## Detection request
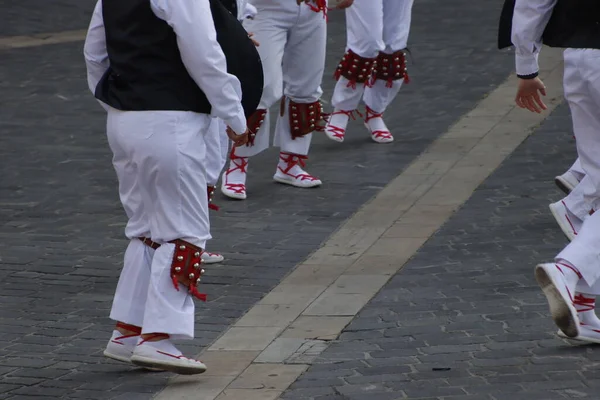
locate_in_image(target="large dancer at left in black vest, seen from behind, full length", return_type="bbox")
[84,0,262,374]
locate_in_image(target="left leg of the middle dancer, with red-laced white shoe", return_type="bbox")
[221,10,287,200]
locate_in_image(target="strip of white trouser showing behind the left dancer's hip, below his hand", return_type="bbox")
[206,118,229,186]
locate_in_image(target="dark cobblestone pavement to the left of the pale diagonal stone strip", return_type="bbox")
[0,0,516,400]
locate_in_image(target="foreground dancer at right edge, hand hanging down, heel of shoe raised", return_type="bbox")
[508,0,600,340]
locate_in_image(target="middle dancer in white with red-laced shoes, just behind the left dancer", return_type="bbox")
[221,0,352,200]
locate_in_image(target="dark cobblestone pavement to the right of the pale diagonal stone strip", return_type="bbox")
[282,105,600,400]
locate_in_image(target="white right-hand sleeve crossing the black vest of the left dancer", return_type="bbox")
[150,0,246,134]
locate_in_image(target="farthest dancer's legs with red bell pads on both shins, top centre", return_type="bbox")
[325,0,413,143]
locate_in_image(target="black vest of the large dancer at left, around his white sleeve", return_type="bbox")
[95,0,264,116]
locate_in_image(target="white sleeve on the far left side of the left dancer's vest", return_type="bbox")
[83,0,110,108]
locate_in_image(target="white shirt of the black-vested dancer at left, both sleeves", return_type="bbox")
[84,0,246,134]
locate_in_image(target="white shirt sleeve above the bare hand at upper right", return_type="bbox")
[511,0,557,75]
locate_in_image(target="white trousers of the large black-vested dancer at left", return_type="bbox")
[107,109,211,338]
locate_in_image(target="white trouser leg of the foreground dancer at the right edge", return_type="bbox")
[557,49,600,290]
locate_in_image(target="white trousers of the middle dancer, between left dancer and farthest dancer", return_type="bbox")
[235,0,327,157]
